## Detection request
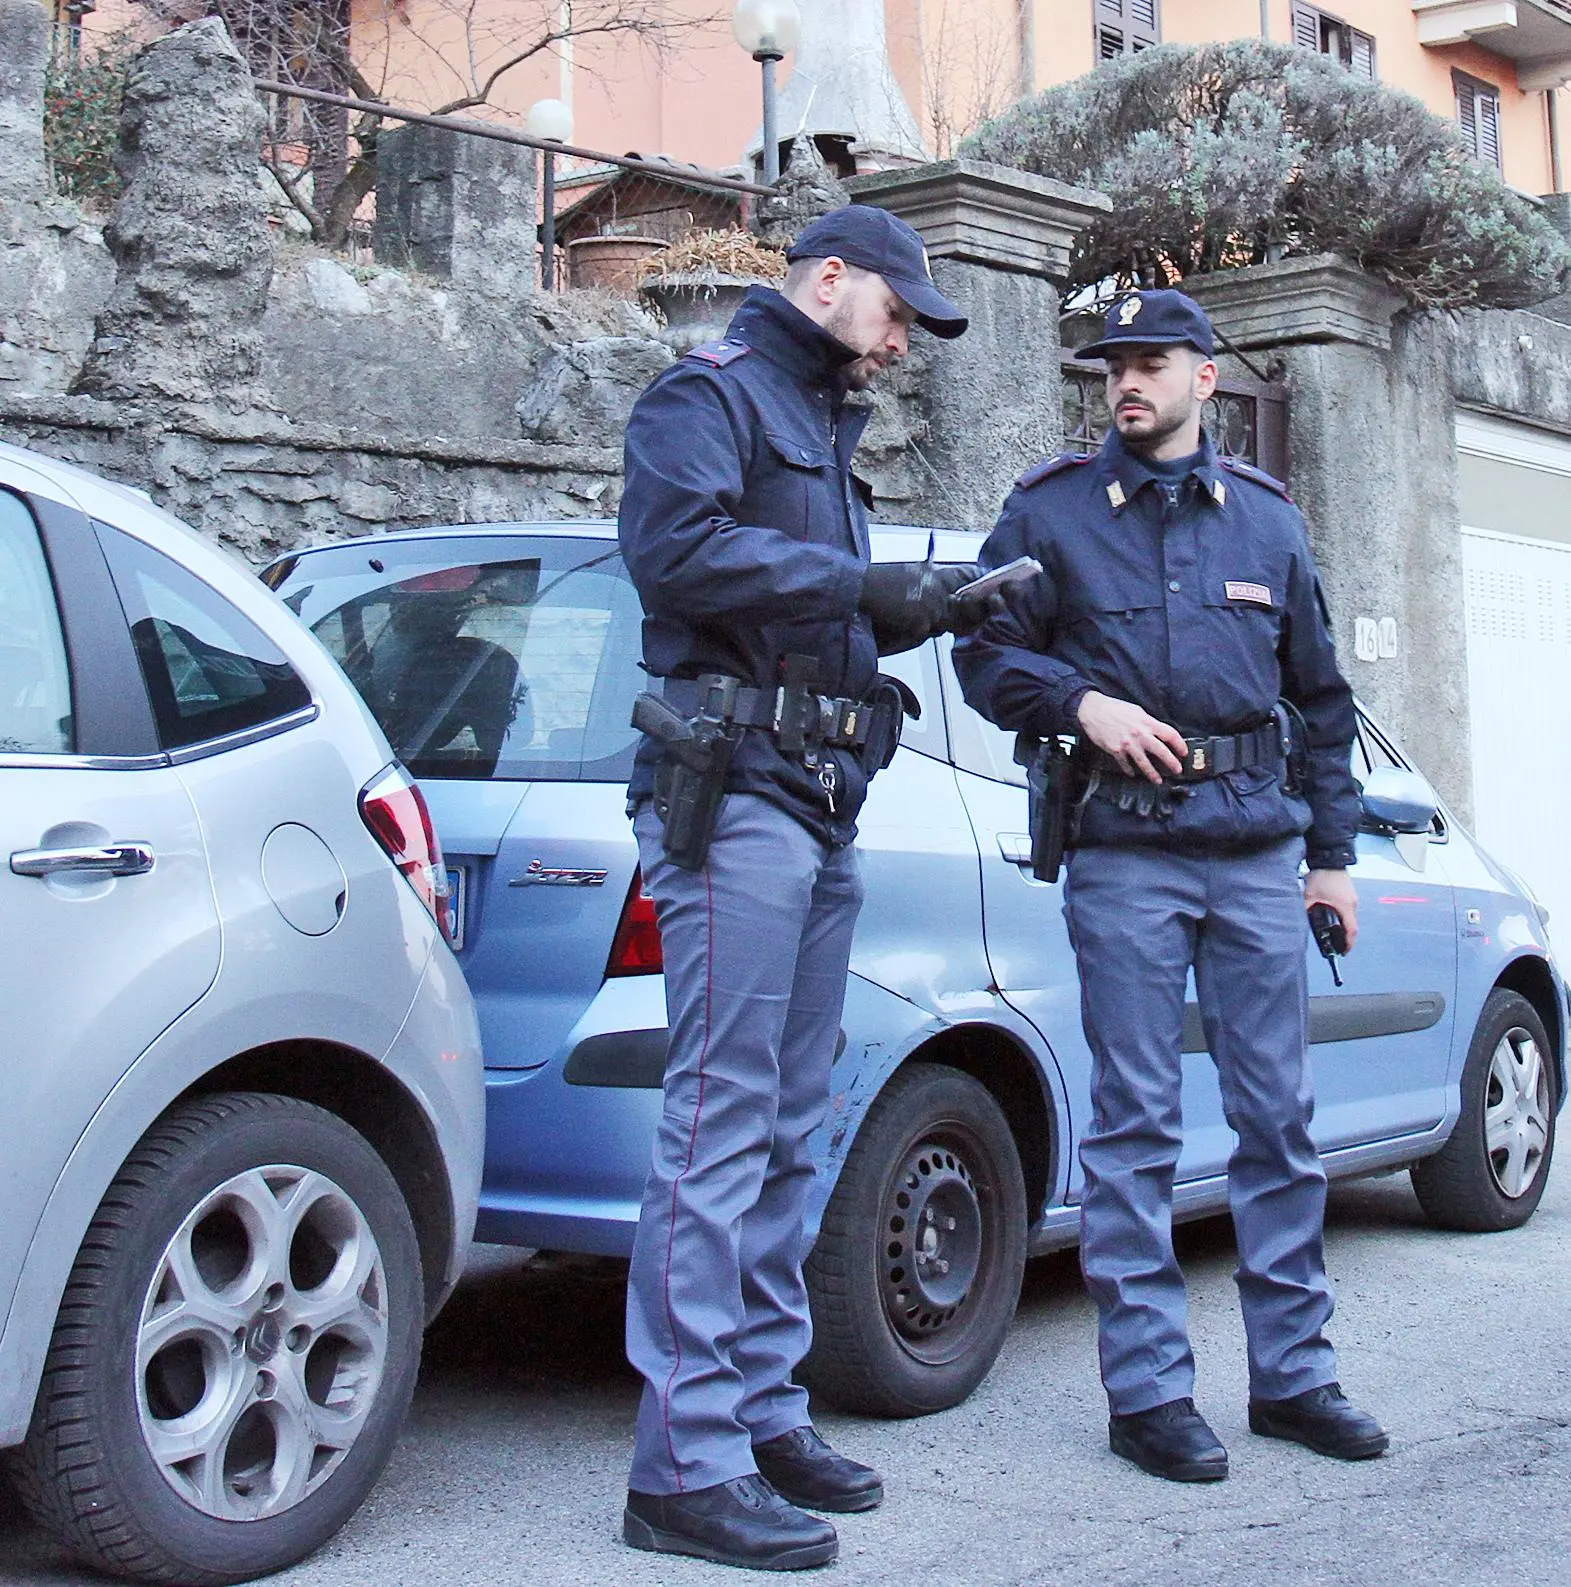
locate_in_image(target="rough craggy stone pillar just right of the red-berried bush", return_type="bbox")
[76,17,273,411]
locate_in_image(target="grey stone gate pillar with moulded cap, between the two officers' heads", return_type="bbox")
[847,160,1109,528]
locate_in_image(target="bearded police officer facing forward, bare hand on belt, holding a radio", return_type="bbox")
[955,292,1387,1482]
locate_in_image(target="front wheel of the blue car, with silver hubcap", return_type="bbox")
[1412,989,1557,1232]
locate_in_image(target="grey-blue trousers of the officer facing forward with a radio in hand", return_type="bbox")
[1065,838,1336,1414]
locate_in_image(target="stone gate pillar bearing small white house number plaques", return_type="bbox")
[1185,256,1473,819]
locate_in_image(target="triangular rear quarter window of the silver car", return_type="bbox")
[95,524,311,749]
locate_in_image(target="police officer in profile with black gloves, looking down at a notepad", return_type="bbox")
[620,205,982,1570]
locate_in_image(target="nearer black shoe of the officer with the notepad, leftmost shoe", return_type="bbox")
[622,1476,839,1571]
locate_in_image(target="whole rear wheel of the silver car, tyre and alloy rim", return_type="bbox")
[13,1092,424,1587]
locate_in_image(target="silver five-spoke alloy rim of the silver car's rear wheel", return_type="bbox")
[136,1165,387,1522]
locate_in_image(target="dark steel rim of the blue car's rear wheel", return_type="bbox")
[879,1136,987,1363]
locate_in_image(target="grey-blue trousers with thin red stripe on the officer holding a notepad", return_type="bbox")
[627,794,862,1493]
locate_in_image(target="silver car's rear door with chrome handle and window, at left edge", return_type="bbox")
[0,485,219,1339]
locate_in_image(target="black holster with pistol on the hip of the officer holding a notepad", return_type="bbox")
[633,673,743,871]
